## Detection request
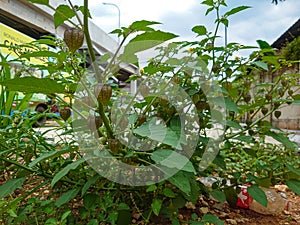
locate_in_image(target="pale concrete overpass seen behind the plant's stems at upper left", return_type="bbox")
[0,0,137,91]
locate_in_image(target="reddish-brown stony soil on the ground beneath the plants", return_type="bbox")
[0,171,300,225]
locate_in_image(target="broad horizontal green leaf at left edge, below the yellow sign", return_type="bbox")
[0,77,66,94]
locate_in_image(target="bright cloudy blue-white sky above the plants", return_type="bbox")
[72,0,300,51]
